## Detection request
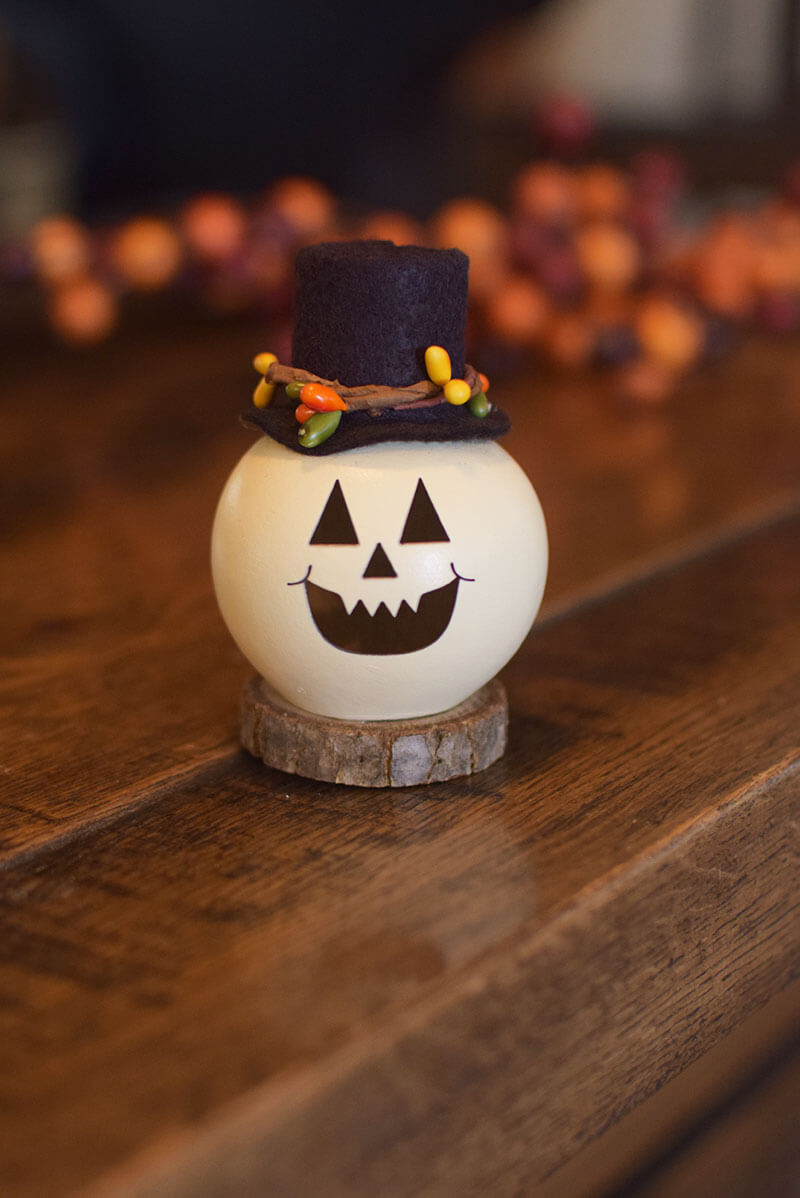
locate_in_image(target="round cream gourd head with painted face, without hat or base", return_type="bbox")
[212,437,547,720]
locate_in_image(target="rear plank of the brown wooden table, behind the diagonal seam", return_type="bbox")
[0,320,800,858]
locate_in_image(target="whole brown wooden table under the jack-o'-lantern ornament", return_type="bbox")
[0,319,800,1198]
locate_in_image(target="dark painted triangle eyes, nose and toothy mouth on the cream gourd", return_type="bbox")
[289,478,474,657]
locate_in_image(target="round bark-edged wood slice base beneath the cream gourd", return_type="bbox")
[240,674,508,786]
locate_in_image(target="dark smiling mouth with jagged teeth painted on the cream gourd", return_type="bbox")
[297,567,462,657]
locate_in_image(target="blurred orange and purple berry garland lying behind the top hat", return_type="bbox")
[0,139,800,405]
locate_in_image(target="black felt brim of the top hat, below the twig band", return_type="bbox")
[241,392,511,456]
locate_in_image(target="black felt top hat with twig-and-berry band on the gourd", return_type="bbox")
[243,241,509,455]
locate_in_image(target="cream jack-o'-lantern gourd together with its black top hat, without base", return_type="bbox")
[212,242,547,785]
